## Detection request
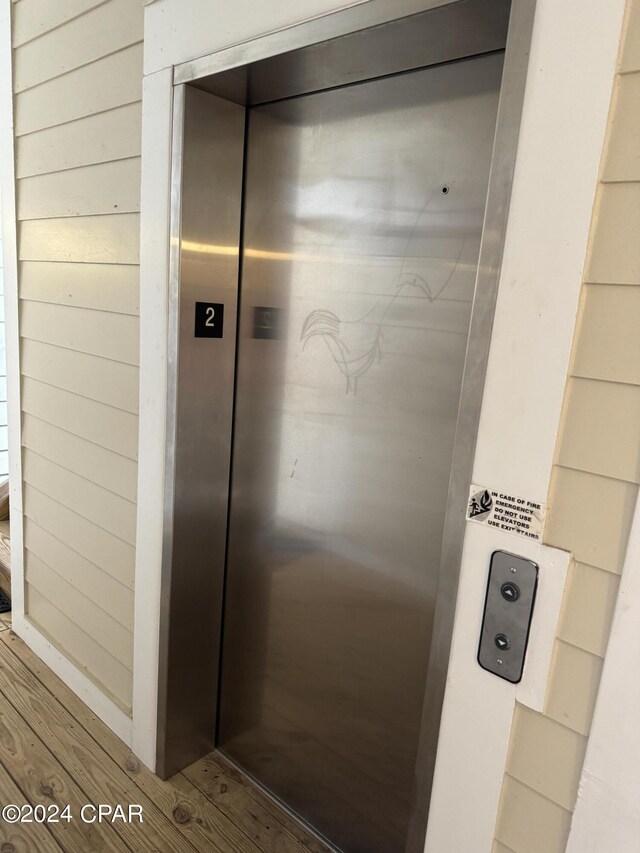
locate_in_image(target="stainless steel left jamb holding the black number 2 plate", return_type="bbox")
[157,87,244,777]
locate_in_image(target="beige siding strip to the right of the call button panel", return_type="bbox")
[494,0,640,853]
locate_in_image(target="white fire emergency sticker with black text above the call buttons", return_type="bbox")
[467,485,547,539]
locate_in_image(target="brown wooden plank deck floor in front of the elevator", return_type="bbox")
[0,616,328,853]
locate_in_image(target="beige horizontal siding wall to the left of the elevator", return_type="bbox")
[13,0,143,711]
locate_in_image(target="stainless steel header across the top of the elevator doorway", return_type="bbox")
[185,0,510,106]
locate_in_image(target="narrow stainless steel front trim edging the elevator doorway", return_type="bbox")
[157,6,536,853]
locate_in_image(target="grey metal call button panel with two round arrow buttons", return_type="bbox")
[478,551,538,684]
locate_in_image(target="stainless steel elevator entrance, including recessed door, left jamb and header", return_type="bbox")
[159,0,524,853]
